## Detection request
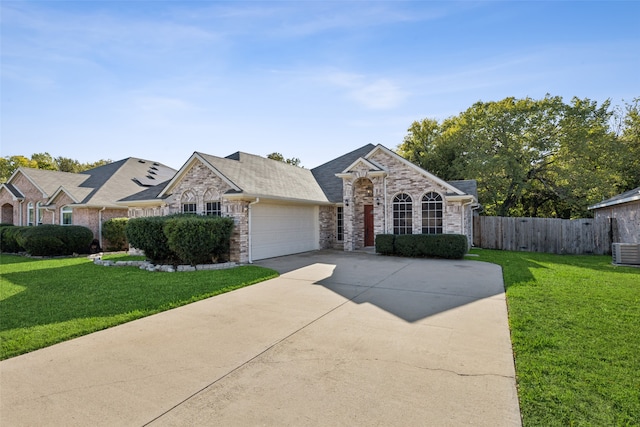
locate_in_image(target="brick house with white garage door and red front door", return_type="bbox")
[118,144,477,263]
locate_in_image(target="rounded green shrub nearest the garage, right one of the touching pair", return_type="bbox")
[163,216,233,265]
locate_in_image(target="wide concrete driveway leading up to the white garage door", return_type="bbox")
[0,251,521,426]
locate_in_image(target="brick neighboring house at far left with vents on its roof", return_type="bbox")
[0,158,176,246]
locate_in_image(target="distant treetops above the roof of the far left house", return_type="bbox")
[0,153,112,182]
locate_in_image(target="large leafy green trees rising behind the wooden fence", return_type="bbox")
[398,95,640,218]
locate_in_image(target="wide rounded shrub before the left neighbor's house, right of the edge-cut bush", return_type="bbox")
[17,224,93,256]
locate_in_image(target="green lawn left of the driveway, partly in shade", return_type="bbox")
[0,255,278,360]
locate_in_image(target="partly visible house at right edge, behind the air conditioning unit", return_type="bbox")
[589,187,640,244]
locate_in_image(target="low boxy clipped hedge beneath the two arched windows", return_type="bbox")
[376,234,468,259]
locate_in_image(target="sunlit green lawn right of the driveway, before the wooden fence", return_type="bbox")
[472,250,640,427]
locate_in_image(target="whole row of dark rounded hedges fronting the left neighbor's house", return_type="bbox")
[0,224,93,256]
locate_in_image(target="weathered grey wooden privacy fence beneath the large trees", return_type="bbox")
[473,216,615,255]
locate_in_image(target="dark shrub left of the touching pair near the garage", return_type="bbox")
[124,215,177,263]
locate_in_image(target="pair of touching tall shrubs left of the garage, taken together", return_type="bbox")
[125,214,234,265]
